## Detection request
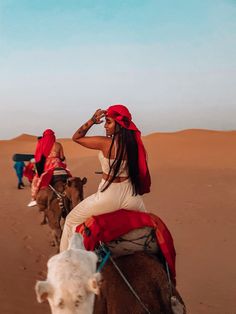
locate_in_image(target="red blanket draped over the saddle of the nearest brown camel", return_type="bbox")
[76,209,176,282]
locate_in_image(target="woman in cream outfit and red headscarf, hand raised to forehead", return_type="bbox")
[60,105,151,251]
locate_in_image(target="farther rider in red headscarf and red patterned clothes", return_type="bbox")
[28,129,69,207]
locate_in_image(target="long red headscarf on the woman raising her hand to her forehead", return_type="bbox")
[106,104,151,195]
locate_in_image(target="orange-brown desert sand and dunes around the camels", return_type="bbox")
[0,130,236,314]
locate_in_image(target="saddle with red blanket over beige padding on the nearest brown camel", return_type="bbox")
[75,209,176,282]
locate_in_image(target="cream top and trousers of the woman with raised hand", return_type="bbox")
[60,151,146,252]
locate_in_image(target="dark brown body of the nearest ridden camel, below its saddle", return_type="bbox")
[93,252,186,314]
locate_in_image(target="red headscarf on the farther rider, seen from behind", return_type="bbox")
[34,129,56,162]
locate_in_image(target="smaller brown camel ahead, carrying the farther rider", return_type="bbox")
[36,177,87,247]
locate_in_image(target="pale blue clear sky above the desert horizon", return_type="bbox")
[0,0,236,139]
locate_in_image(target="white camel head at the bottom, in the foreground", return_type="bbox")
[35,233,101,314]
